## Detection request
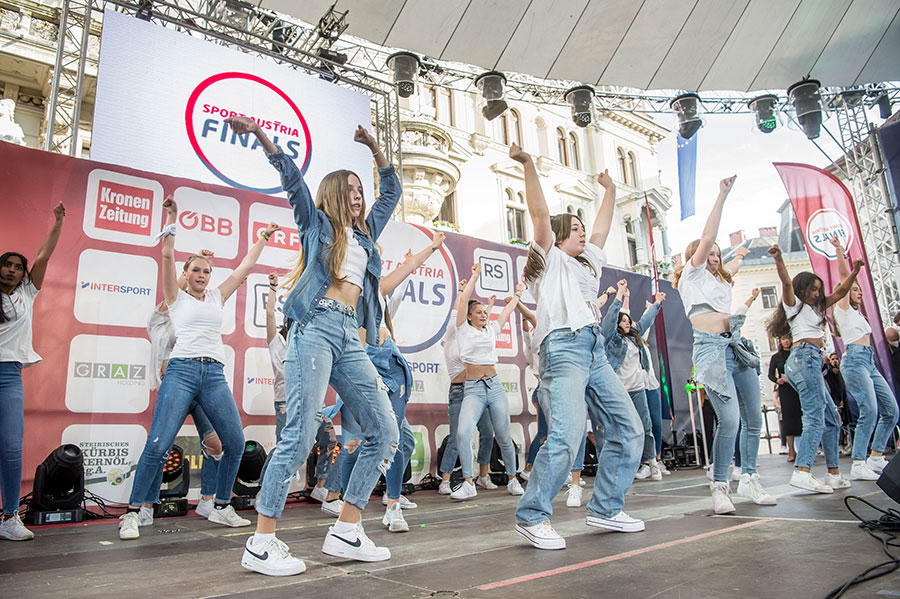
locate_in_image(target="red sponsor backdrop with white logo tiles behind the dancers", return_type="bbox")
[0,144,691,502]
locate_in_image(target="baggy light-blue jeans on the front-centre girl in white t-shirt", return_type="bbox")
[516,325,643,526]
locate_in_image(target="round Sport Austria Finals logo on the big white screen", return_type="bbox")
[184,73,312,193]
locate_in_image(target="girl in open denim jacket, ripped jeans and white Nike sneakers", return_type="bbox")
[226,117,401,576]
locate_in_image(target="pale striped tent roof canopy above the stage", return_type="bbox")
[262,0,900,91]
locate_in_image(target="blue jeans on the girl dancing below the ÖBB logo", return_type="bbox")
[129,358,244,506]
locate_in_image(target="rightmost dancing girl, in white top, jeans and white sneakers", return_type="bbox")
[831,237,898,480]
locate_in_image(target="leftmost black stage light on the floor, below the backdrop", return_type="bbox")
[29,444,84,524]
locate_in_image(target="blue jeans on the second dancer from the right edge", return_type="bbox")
[784,343,841,468]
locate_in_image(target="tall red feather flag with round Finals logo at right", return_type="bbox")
[773,162,893,394]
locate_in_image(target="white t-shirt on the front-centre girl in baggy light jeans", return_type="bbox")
[531,236,606,349]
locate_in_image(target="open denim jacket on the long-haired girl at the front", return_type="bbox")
[269,148,402,345]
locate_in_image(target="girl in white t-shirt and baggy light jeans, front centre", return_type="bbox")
[509,144,644,549]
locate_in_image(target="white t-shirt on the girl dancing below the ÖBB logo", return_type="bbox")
[169,288,225,364]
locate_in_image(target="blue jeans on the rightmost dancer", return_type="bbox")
[841,343,898,460]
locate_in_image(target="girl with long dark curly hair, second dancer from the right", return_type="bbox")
[766,245,863,493]
